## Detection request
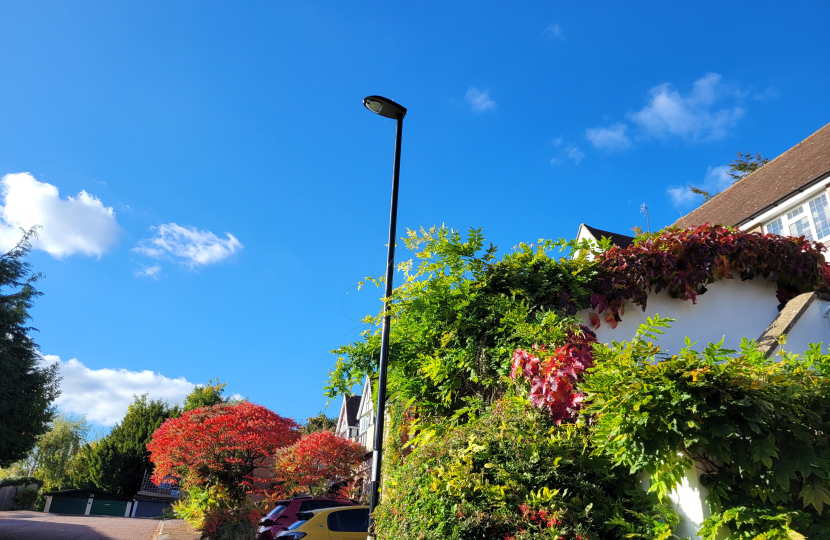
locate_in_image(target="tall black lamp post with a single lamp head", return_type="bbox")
[363,96,406,528]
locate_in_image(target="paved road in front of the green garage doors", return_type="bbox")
[0,511,160,540]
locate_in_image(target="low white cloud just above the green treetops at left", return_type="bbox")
[48,355,196,426]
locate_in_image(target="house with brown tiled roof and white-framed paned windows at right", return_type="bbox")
[674,124,830,245]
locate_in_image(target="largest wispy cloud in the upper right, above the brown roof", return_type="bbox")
[630,73,744,140]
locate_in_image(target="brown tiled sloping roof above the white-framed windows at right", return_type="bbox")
[674,124,830,227]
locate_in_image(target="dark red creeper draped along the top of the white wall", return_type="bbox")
[590,224,830,328]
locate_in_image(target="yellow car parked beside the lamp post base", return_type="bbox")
[275,506,369,540]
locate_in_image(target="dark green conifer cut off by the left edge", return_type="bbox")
[0,228,60,467]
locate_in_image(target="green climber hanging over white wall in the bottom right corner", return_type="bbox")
[580,326,830,540]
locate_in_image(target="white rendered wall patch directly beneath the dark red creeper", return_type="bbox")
[579,278,784,354]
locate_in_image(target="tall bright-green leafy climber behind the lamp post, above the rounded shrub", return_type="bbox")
[326,227,607,416]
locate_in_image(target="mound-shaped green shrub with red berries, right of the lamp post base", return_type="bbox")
[374,399,677,540]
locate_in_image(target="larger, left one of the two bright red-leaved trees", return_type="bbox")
[147,401,299,501]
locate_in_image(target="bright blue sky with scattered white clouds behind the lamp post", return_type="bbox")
[0,1,830,426]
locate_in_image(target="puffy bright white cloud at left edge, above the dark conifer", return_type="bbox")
[0,173,121,259]
